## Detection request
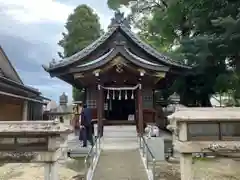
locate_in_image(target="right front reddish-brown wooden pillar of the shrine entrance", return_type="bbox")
[138,84,144,136]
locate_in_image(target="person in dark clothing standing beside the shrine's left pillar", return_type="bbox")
[80,105,93,147]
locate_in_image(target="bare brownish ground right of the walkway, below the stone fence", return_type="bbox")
[157,159,240,180]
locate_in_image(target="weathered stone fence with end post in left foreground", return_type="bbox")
[0,121,73,180]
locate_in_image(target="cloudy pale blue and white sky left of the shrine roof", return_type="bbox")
[0,0,113,101]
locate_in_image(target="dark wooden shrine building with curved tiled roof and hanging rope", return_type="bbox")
[43,13,190,132]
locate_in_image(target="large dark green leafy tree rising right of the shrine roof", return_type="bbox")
[108,0,240,106]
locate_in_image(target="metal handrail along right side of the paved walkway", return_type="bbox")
[139,136,156,180]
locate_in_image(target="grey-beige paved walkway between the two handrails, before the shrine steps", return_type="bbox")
[93,149,148,180]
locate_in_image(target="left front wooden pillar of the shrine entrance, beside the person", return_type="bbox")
[97,83,103,137]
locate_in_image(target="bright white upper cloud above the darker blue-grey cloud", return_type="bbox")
[0,0,112,46]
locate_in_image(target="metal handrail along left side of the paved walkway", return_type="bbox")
[84,135,101,170]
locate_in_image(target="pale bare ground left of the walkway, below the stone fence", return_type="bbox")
[0,159,84,180]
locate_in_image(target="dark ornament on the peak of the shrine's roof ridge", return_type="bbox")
[109,10,131,29]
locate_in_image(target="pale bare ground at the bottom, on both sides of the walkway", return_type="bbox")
[0,155,240,180]
